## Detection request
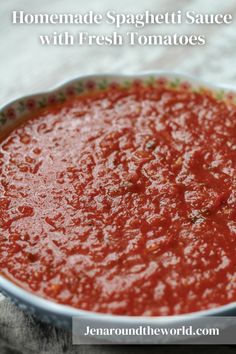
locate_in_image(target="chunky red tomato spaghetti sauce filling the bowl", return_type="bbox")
[0,83,236,315]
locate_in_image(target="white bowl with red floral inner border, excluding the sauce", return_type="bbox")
[0,72,236,338]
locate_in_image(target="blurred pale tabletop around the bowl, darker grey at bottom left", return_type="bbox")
[0,0,236,354]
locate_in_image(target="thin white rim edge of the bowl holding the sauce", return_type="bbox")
[0,70,236,324]
